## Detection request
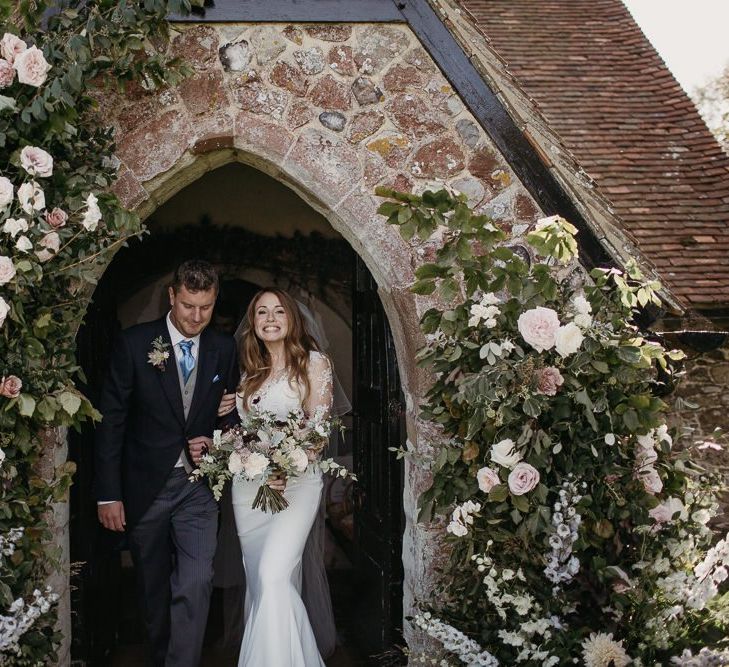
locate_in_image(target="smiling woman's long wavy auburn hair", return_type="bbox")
[238,287,320,406]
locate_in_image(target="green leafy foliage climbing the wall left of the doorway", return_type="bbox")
[0,0,189,665]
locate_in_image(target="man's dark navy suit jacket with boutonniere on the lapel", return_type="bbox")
[94,317,239,530]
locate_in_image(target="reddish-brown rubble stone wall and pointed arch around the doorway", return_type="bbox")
[56,19,552,664]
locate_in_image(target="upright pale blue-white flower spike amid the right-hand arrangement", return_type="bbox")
[544,476,582,588]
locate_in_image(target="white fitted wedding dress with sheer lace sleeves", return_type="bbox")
[232,352,332,667]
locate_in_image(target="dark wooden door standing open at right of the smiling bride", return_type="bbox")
[352,257,404,662]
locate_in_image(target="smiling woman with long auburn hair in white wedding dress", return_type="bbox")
[225,288,333,667]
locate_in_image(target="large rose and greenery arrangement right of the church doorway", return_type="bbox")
[378,189,729,667]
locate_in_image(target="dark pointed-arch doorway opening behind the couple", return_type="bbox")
[69,163,404,665]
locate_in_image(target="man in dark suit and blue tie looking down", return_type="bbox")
[95,260,239,667]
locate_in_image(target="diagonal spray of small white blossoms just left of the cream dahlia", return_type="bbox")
[471,552,563,667]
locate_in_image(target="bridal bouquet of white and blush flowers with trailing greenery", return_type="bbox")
[191,411,356,514]
